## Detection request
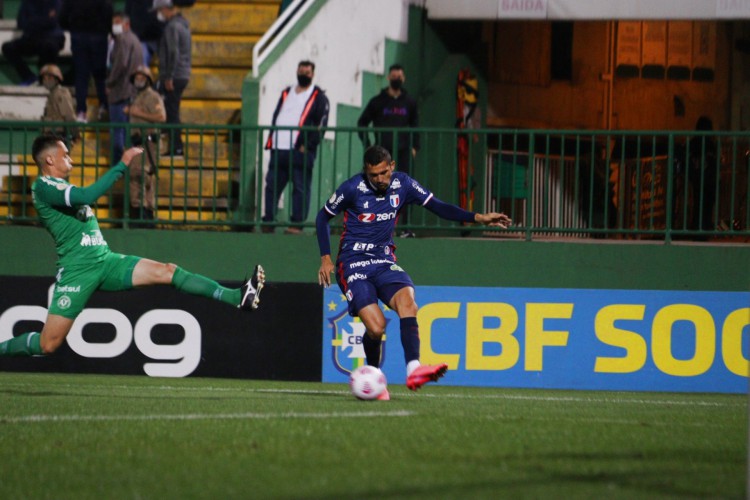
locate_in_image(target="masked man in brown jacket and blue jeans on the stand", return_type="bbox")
[106,12,143,163]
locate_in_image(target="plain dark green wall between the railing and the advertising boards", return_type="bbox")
[0,226,750,293]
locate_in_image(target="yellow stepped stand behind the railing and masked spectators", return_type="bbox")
[0,0,280,227]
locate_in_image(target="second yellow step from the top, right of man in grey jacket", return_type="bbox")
[192,35,260,70]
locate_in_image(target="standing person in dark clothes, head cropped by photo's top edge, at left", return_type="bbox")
[60,0,112,123]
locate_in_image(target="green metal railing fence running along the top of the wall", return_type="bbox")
[0,122,750,242]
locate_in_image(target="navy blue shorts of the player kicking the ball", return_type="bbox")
[336,255,414,316]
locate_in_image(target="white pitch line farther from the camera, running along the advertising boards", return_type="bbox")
[3,383,747,407]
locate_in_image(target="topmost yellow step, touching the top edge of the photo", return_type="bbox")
[183,1,279,36]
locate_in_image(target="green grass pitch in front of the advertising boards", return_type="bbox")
[0,373,748,500]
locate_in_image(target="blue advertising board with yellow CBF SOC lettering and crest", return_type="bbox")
[323,286,750,393]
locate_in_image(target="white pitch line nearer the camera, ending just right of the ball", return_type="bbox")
[0,410,415,424]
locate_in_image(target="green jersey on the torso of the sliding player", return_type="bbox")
[31,175,109,267]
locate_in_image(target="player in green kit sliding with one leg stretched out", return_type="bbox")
[0,135,265,356]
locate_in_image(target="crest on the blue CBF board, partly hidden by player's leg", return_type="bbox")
[328,309,386,375]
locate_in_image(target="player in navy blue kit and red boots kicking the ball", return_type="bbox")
[316,145,511,399]
